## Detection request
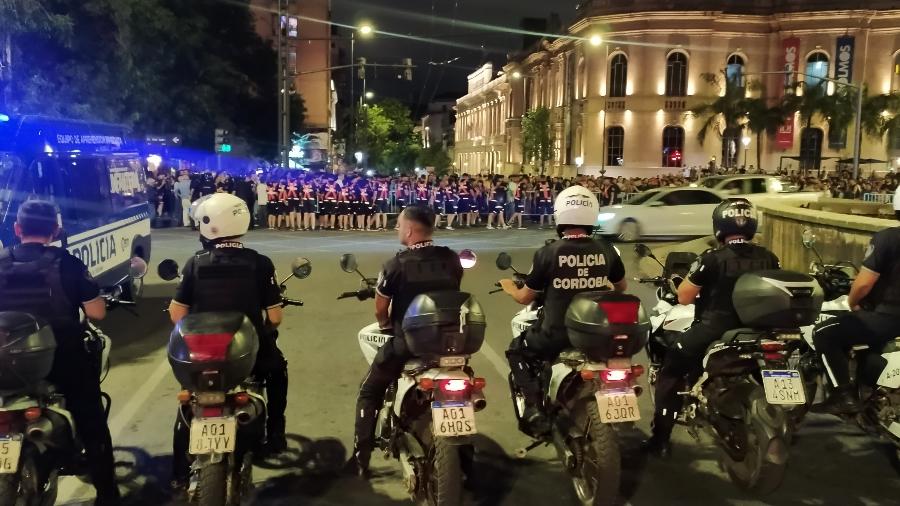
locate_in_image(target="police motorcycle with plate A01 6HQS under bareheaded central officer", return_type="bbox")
[338,250,487,506]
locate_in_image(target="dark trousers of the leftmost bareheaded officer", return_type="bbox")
[48,339,119,505]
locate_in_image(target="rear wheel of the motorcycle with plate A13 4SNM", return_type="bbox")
[723,387,788,496]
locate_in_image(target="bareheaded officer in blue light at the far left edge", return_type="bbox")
[0,200,120,505]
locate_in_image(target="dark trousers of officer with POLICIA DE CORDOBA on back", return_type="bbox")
[506,321,572,407]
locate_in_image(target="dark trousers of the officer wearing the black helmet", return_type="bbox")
[653,320,735,441]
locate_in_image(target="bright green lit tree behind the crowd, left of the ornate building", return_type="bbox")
[357,99,422,172]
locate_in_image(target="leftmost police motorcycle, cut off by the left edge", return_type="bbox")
[0,257,147,506]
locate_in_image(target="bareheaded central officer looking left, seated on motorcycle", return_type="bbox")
[347,205,463,478]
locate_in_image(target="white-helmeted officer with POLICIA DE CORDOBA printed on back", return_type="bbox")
[500,186,627,436]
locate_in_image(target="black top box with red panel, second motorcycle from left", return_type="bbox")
[168,311,259,392]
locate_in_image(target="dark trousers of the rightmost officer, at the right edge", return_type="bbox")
[813,311,900,386]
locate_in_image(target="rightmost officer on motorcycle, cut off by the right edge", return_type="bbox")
[812,188,900,415]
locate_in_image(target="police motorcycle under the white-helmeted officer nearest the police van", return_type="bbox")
[158,258,312,506]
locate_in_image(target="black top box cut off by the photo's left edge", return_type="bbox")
[0,311,56,391]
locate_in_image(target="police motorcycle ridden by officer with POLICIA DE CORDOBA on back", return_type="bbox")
[491,253,650,506]
